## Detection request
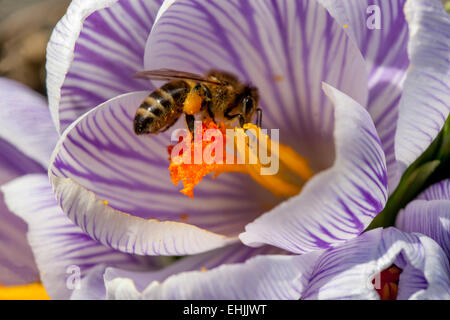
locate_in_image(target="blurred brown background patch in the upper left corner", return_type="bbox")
[0,0,70,94]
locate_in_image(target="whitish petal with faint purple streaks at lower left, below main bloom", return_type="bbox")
[2,174,154,299]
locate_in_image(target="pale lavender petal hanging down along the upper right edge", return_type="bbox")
[395,0,450,171]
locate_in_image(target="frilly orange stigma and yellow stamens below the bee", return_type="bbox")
[168,121,313,198]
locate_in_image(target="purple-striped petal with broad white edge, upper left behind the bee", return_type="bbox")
[47,0,162,132]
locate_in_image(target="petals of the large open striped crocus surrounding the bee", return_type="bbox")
[47,0,386,255]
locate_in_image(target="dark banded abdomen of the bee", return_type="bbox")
[134,80,191,134]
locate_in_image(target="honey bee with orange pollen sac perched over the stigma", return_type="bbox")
[134,69,262,135]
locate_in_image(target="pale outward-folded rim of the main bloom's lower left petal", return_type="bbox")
[51,171,236,255]
